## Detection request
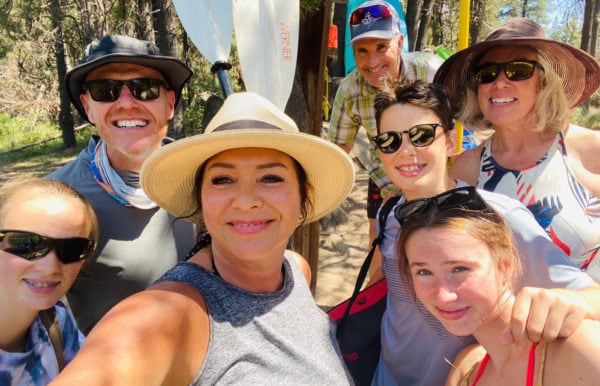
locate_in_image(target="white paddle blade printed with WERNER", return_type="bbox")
[233,0,300,111]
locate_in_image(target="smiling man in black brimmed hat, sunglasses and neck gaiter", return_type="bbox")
[47,35,194,334]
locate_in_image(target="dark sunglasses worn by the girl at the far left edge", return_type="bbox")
[0,230,95,264]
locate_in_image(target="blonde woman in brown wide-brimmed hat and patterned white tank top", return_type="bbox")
[434,18,600,281]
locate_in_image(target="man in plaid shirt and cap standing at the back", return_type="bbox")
[325,0,442,282]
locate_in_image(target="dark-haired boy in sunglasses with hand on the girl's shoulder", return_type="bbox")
[373,81,600,385]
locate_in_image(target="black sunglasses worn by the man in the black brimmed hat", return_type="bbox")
[83,78,167,102]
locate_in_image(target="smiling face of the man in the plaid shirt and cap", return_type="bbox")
[352,35,404,88]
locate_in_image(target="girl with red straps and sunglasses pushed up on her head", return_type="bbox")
[396,198,600,386]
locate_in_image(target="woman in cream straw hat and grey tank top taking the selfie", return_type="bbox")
[51,93,354,385]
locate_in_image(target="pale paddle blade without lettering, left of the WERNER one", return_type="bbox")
[173,0,233,64]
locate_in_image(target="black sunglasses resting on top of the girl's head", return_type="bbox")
[394,186,487,225]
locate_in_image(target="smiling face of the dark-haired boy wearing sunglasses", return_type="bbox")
[378,104,455,200]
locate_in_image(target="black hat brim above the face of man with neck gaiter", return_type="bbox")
[65,53,192,121]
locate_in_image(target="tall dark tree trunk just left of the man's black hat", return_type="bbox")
[49,0,77,148]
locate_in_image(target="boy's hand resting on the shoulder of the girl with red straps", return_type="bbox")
[511,287,589,347]
